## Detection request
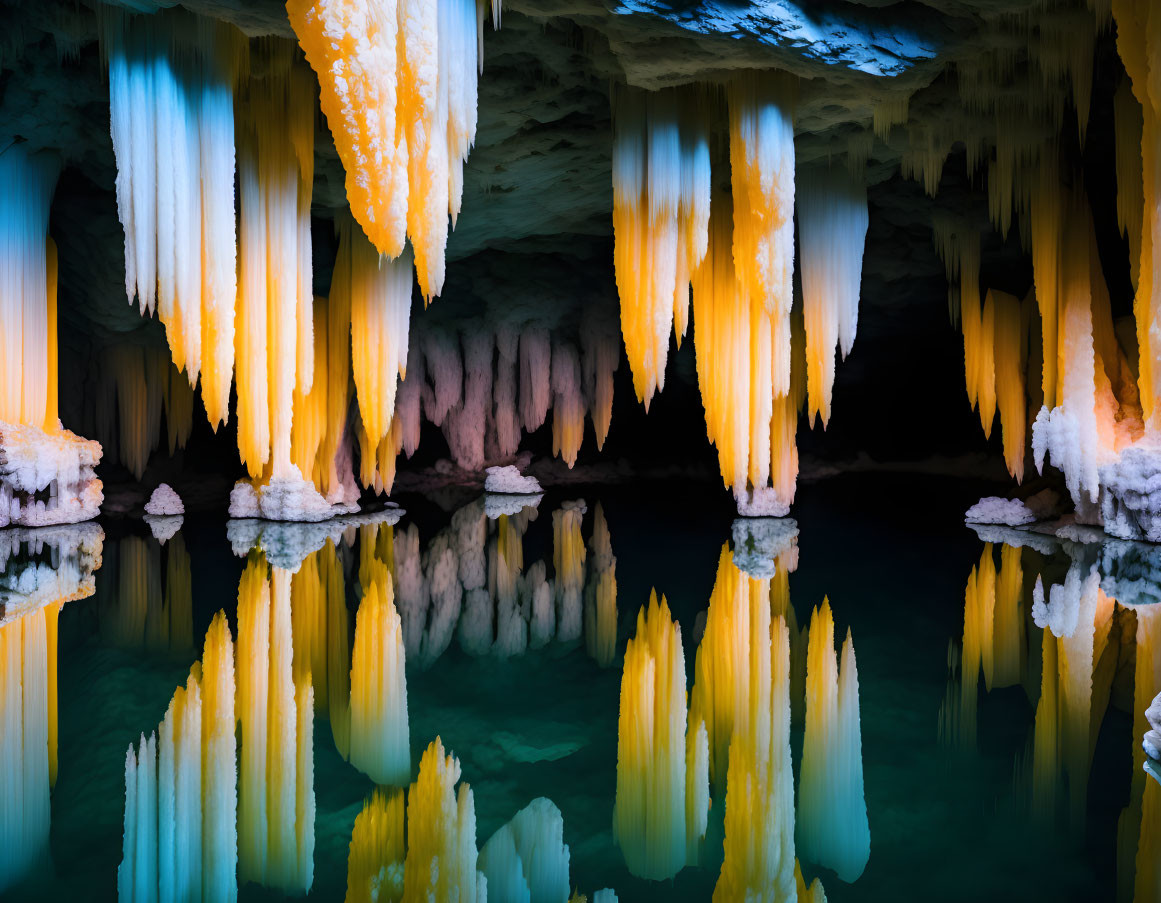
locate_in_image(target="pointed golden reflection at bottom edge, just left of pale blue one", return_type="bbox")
[403,737,486,903]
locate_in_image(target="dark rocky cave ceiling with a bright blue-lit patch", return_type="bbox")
[0,0,1127,436]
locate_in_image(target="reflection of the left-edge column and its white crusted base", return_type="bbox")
[0,523,104,894]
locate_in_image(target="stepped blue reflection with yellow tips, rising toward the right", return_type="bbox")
[117,612,238,901]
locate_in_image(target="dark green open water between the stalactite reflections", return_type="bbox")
[0,477,1147,903]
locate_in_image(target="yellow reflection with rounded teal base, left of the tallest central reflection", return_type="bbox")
[613,591,709,881]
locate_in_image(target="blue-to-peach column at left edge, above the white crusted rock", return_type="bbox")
[0,143,60,433]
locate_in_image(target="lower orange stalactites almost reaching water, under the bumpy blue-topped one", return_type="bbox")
[693,192,806,506]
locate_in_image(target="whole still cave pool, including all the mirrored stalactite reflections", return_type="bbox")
[0,477,1161,903]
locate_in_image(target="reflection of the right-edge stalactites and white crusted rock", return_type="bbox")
[939,530,1161,903]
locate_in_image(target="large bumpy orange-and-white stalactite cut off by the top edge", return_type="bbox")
[287,0,500,301]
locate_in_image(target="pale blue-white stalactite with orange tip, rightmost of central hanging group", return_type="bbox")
[796,167,868,426]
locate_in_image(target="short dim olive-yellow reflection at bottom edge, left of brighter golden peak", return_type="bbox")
[346,787,405,903]
